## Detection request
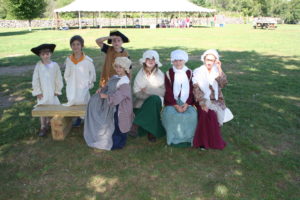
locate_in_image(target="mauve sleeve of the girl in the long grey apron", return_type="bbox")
[108,84,131,105]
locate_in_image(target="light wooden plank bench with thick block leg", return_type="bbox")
[31,105,86,140]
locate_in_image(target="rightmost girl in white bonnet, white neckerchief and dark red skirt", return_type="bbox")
[193,49,233,149]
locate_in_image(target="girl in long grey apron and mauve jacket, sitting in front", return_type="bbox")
[84,57,133,150]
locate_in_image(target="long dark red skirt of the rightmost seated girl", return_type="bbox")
[193,106,226,149]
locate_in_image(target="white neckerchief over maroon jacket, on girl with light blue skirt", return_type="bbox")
[173,66,190,103]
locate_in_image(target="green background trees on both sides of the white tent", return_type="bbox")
[0,0,300,24]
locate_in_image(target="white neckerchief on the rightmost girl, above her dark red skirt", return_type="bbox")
[193,65,219,100]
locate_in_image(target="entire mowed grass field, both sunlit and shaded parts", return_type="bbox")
[0,25,300,200]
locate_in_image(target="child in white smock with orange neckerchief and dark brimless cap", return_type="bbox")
[64,35,96,126]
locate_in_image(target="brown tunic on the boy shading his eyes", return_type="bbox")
[99,44,129,87]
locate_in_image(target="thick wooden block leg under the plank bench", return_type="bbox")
[51,116,72,140]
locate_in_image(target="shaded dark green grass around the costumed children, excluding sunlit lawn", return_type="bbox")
[0,46,300,199]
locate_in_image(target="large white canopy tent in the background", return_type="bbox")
[54,0,216,27]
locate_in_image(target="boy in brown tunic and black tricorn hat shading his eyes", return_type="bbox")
[96,31,129,88]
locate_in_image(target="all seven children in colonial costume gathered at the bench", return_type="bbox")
[31,31,233,150]
